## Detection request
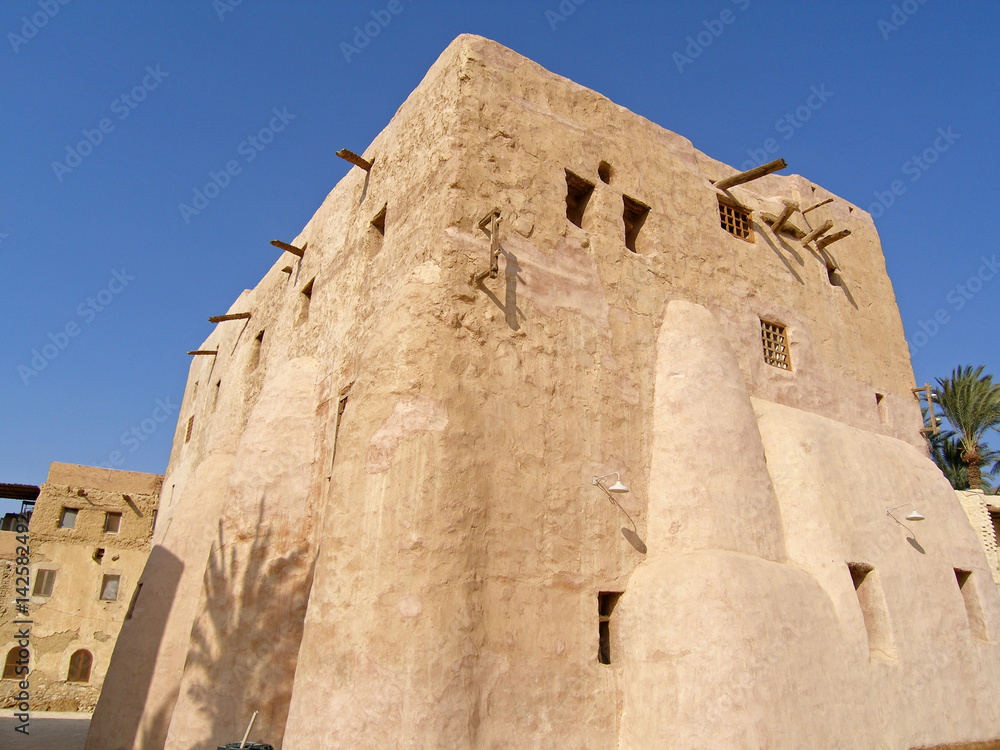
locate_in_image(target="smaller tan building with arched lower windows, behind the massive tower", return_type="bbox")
[0,463,163,711]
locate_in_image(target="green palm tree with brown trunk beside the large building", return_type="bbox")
[934,365,1000,490]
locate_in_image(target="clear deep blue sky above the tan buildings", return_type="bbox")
[0,0,1000,509]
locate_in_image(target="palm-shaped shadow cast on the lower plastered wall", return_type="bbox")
[184,498,315,750]
